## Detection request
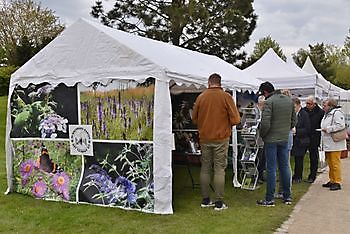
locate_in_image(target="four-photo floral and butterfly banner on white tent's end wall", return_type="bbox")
[11,79,154,212]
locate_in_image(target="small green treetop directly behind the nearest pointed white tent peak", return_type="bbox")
[240,36,287,69]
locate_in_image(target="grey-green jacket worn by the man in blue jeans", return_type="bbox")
[260,90,296,143]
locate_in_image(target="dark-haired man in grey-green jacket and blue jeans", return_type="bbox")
[257,82,296,206]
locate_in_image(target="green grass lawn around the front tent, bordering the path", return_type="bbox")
[0,94,309,233]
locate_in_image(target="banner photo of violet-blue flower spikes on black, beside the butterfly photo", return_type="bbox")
[79,143,154,212]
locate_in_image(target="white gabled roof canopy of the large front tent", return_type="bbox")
[10,19,261,90]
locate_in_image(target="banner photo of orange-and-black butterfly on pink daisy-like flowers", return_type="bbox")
[12,140,82,202]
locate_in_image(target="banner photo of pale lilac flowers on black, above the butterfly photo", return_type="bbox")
[11,83,78,138]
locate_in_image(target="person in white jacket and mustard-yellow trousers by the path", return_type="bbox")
[321,98,346,191]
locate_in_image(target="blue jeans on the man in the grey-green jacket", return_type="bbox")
[264,142,291,201]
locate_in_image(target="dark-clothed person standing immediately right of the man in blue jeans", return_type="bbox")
[292,98,310,183]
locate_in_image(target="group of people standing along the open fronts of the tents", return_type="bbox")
[192,73,346,211]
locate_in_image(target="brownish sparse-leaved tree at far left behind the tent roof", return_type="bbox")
[0,0,64,66]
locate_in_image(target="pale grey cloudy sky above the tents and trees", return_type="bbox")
[35,0,350,55]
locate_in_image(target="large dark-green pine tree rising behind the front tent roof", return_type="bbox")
[91,0,257,63]
